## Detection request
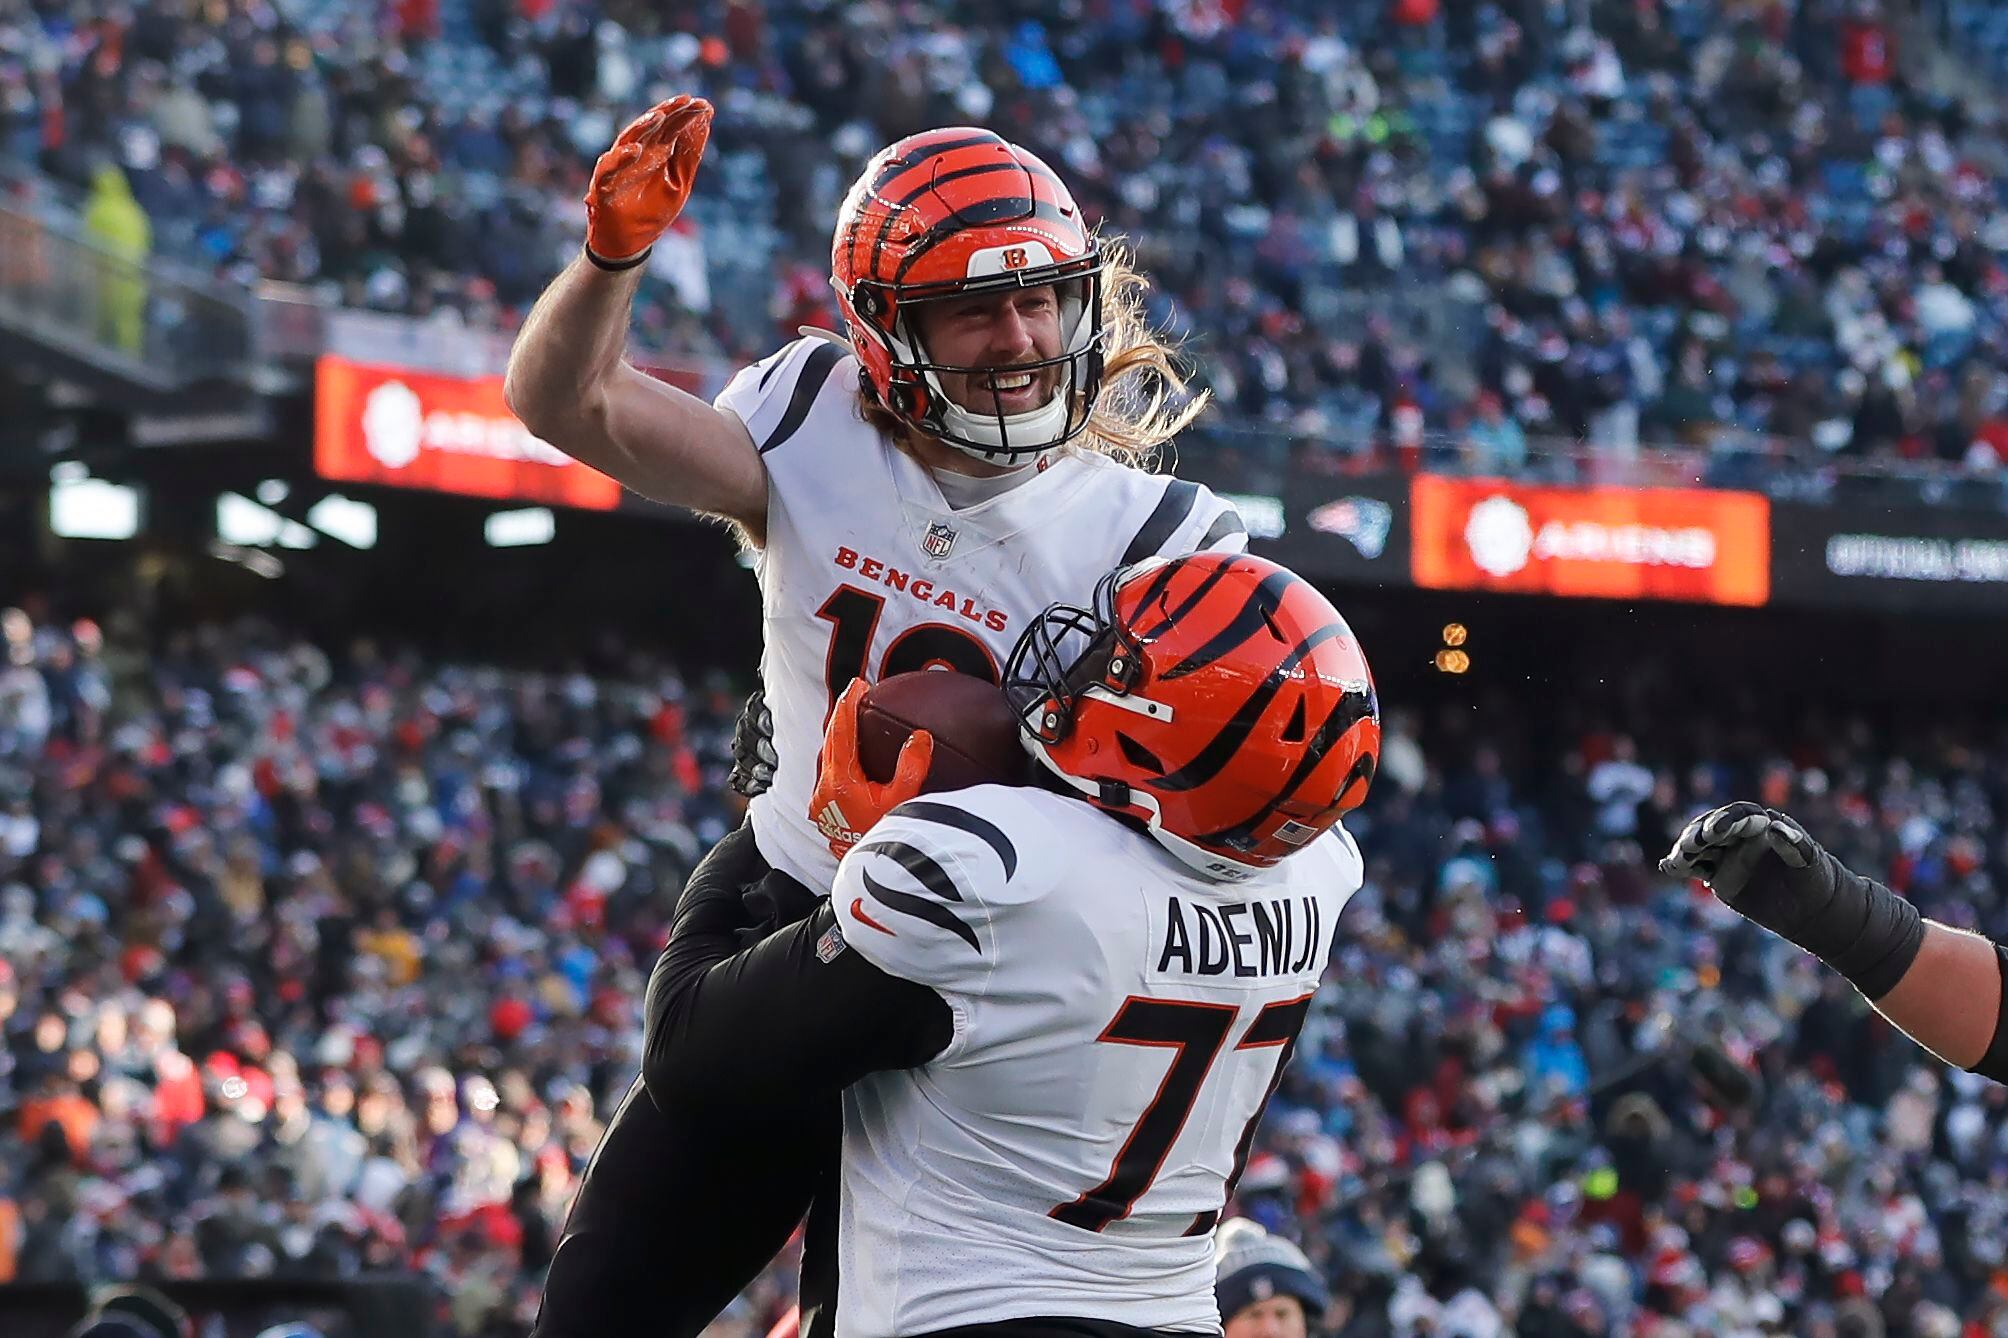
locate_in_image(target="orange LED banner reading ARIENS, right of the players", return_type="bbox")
[1410,474,1771,605]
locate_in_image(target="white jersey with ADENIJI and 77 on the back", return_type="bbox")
[819,786,1361,1338]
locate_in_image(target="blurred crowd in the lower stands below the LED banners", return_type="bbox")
[0,611,2008,1338]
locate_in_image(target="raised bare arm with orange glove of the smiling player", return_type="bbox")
[504,96,767,540]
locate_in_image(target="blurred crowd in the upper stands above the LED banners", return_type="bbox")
[0,0,2008,472]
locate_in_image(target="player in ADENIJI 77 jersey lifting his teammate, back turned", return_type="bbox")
[643,552,1379,1338]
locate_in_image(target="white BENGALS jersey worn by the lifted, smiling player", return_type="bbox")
[717,338,1247,890]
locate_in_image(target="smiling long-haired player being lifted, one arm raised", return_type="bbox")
[506,96,1247,1338]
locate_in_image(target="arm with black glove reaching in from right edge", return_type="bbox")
[1661,804,2008,1083]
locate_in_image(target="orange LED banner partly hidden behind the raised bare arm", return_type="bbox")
[313,356,620,510]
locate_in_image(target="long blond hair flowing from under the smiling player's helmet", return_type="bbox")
[857,239,1213,468]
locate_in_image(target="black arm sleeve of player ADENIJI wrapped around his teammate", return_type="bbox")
[643,882,954,1119]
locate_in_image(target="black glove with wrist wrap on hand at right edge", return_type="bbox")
[1659,802,1924,1000]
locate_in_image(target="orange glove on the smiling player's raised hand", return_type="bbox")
[586,94,711,267]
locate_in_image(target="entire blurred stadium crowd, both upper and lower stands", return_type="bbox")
[0,0,2008,1338]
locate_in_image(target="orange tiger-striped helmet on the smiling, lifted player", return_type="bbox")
[829,127,1104,464]
